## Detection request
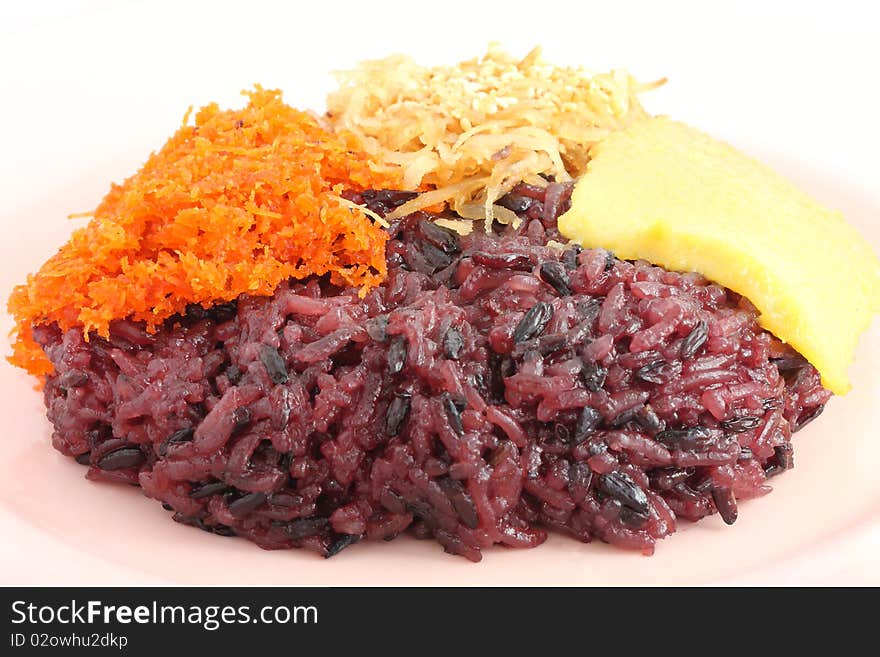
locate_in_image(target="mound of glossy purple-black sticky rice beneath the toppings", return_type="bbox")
[35,183,830,561]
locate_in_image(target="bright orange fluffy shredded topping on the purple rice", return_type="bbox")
[8,87,400,375]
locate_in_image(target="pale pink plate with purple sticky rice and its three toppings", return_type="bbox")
[0,3,880,584]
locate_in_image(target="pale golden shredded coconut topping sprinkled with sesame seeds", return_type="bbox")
[327,45,664,225]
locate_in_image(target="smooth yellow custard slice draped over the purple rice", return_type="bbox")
[559,117,880,394]
